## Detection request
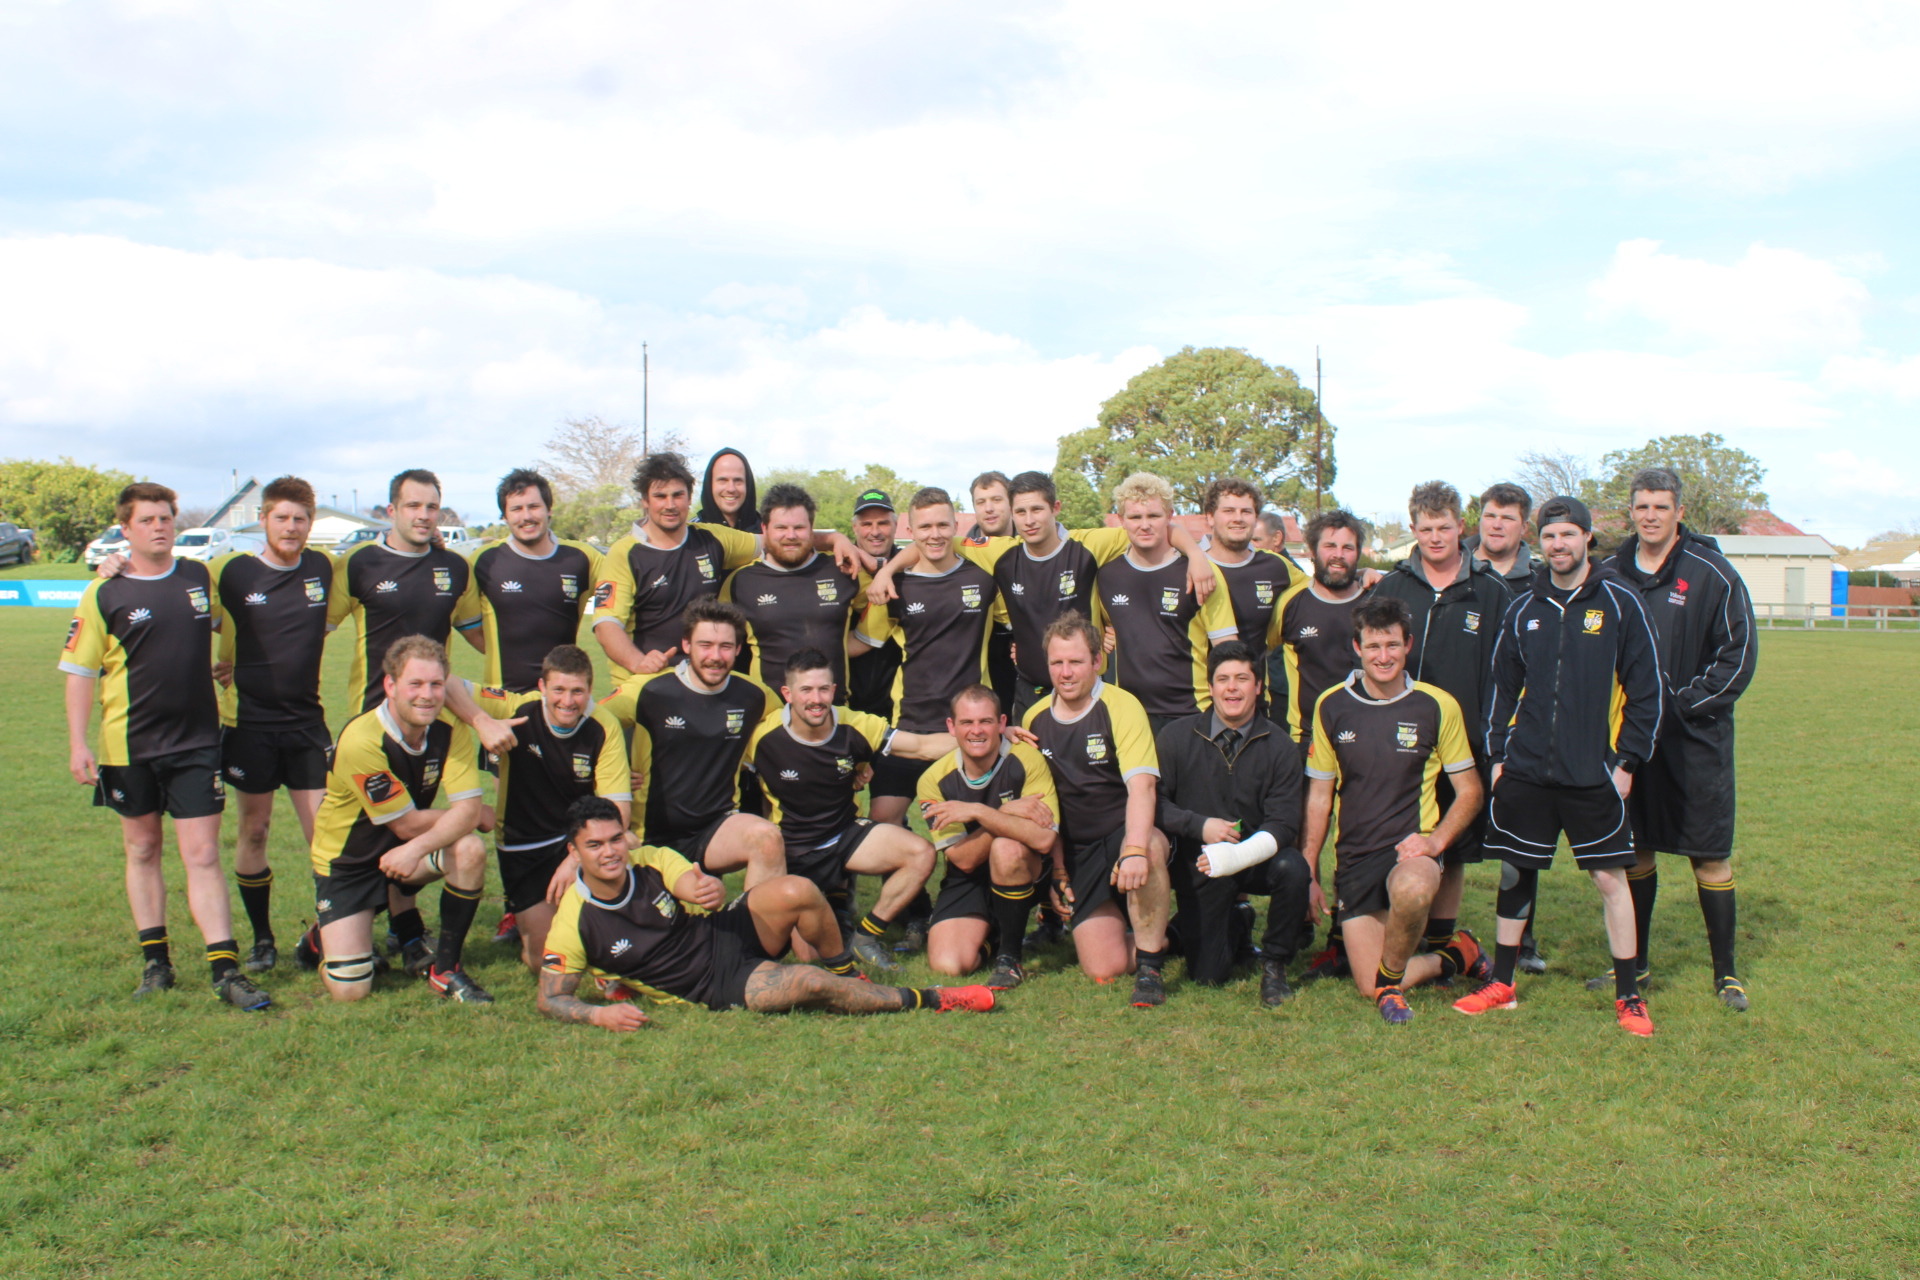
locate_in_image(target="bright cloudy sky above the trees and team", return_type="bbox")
[0,0,1920,543]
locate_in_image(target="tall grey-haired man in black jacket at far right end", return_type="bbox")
[1590,468,1757,1011]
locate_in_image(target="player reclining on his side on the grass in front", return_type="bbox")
[540,796,993,1031]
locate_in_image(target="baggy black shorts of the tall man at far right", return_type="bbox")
[1626,708,1734,862]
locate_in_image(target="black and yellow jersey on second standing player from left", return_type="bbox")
[213,549,334,729]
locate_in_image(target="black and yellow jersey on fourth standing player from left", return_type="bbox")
[474,537,601,693]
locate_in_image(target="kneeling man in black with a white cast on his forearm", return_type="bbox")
[1156,641,1309,1006]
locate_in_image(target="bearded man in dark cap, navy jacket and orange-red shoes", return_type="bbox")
[1453,497,1661,1036]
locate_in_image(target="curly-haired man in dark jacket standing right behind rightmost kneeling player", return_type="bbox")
[1373,480,1513,971]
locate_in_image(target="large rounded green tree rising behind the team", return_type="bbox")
[1054,347,1334,510]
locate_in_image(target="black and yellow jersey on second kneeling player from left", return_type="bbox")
[476,689,634,850]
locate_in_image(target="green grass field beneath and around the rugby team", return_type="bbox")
[0,610,1920,1280]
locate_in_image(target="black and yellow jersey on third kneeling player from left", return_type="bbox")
[601,662,780,844]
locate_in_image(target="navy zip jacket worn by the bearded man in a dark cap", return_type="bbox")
[1486,562,1663,787]
